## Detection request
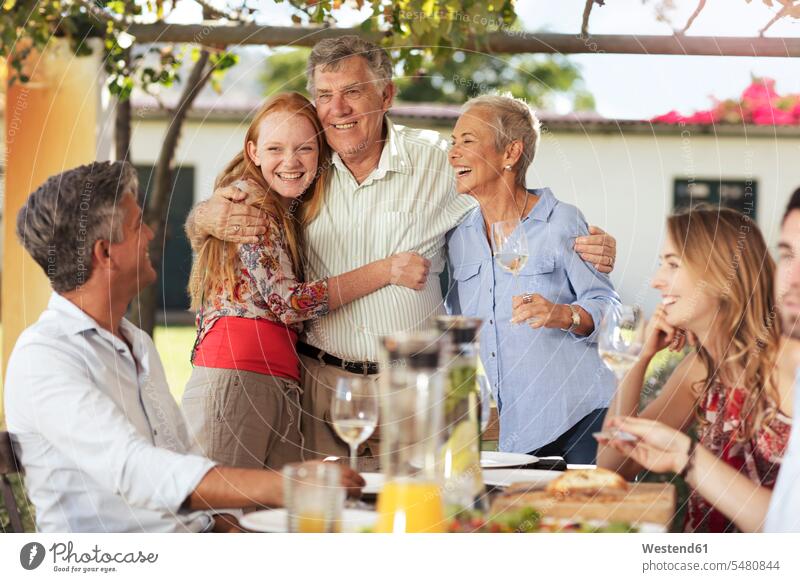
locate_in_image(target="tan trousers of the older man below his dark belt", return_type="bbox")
[300,356,380,470]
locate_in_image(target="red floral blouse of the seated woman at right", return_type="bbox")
[684,383,792,533]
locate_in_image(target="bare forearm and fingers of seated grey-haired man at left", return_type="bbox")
[187,465,365,509]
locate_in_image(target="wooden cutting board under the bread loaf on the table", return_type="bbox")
[492,483,675,529]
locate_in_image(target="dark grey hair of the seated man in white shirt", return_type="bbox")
[17,162,138,293]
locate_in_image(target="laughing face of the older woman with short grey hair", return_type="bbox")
[448,107,503,194]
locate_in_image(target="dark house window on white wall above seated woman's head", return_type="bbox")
[673,179,758,220]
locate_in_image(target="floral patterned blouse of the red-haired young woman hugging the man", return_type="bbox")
[195,212,328,354]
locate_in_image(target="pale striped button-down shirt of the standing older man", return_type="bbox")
[306,119,477,361]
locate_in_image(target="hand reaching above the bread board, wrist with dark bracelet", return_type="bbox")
[597,416,691,473]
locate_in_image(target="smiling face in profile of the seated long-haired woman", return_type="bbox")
[652,236,719,332]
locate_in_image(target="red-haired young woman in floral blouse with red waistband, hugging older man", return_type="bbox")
[183,93,429,469]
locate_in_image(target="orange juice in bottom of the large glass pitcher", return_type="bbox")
[375,481,445,533]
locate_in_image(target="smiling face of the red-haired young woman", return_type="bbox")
[247,111,319,198]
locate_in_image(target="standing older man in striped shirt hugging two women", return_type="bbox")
[187,36,616,466]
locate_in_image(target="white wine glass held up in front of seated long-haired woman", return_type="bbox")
[595,305,645,441]
